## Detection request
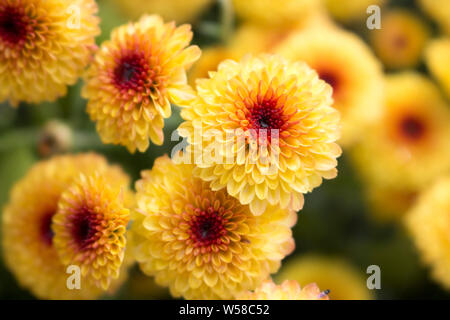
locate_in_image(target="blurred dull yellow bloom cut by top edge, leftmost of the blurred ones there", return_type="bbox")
[113,0,213,23]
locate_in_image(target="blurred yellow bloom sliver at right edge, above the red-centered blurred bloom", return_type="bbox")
[425,38,450,98]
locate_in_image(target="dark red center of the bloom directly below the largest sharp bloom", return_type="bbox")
[190,207,227,247]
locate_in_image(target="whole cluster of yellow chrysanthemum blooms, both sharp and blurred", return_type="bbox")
[0,0,450,300]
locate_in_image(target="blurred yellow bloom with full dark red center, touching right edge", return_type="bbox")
[353,72,450,192]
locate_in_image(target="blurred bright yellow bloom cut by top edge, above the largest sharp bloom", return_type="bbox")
[233,0,322,29]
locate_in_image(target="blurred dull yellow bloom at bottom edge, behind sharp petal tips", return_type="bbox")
[276,255,372,300]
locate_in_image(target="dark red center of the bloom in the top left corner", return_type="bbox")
[0,4,32,45]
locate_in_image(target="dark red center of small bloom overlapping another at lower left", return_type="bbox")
[71,209,98,249]
